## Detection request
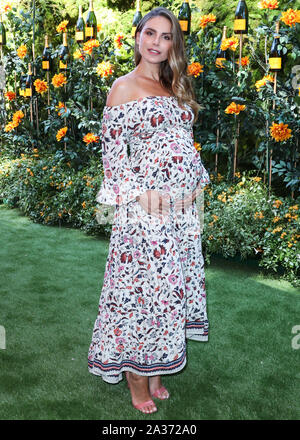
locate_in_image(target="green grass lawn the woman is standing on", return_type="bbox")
[0,206,300,420]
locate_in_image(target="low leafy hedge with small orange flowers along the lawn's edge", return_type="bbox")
[0,153,300,284]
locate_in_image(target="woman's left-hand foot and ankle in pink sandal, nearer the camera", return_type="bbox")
[126,372,157,414]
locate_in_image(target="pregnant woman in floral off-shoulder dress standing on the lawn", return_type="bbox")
[89,7,209,413]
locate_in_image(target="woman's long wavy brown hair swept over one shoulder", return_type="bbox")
[134,6,202,123]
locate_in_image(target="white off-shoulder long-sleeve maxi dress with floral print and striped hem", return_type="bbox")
[88,96,209,383]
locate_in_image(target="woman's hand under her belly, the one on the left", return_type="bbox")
[136,190,170,217]
